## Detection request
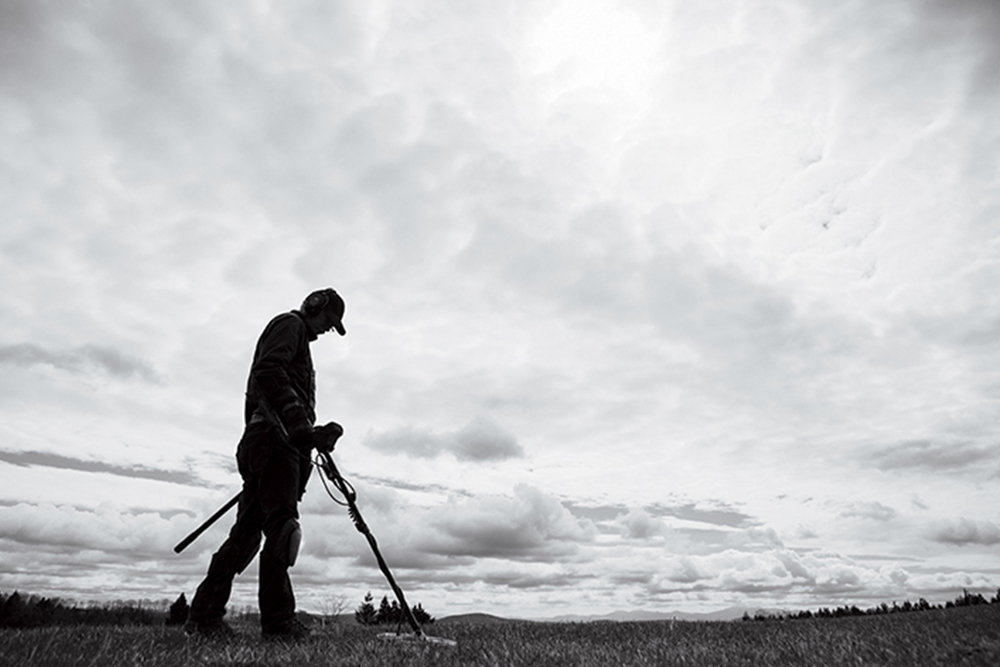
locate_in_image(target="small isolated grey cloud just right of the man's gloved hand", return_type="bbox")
[365,416,524,463]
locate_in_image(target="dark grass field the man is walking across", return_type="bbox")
[0,604,1000,667]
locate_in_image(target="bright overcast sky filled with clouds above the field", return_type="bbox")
[0,0,1000,618]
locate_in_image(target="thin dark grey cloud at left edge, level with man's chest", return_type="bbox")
[0,343,159,382]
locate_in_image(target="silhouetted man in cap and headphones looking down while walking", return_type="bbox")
[185,288,347,639]
